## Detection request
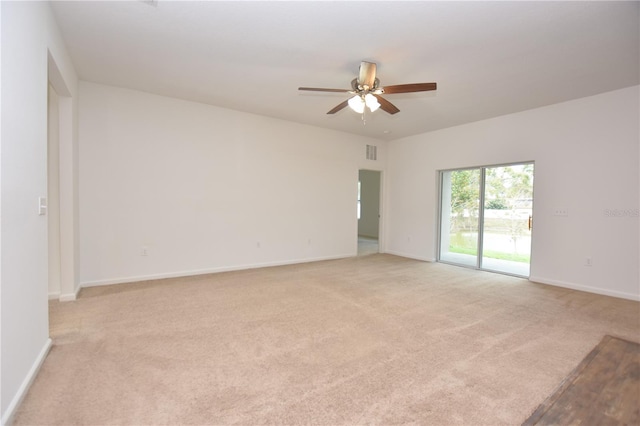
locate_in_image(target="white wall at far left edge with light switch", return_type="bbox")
[0,2,77,423]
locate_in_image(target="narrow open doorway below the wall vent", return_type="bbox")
[357,170,380,256]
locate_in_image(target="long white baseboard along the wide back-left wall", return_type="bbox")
[79,253,354,288]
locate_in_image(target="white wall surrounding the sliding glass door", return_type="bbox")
[387,86,640,299]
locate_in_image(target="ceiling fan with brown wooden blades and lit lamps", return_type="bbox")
[298,61,437,114]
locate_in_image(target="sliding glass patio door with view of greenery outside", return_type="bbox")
[438,162,534,277]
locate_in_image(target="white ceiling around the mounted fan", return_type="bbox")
[52,0,640,140]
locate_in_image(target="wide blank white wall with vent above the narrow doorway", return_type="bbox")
[79,82,386,285]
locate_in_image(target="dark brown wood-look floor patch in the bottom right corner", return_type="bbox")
[523,336,640,426]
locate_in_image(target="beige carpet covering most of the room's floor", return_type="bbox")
[15,254,640,425]
